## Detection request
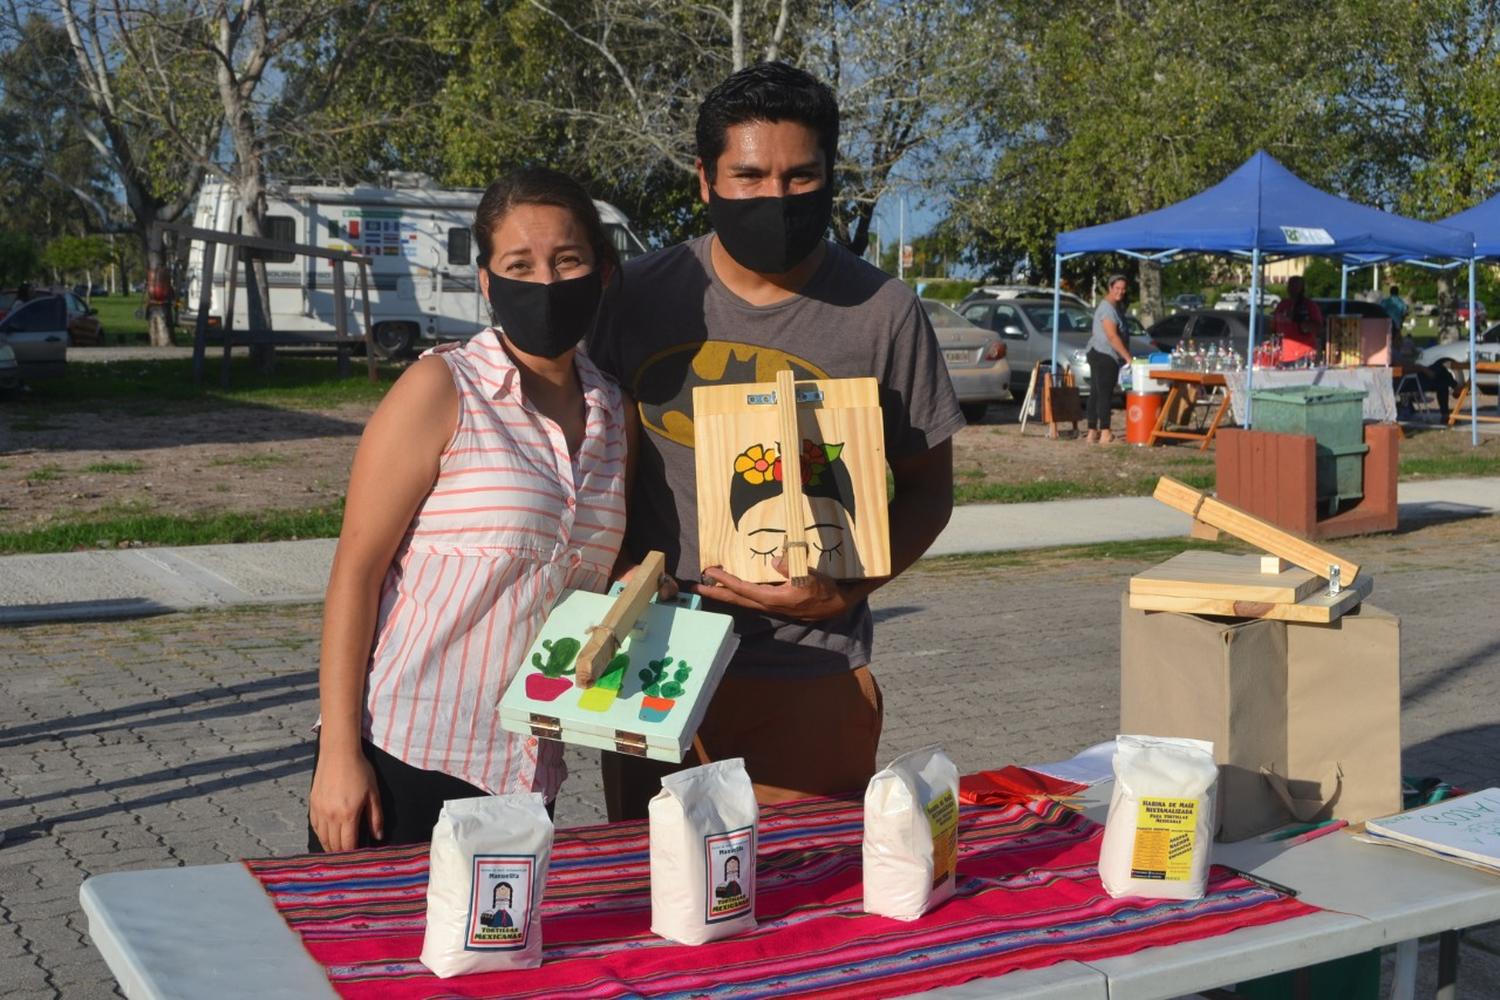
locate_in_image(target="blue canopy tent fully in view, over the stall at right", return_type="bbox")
[1053,151,1475,431]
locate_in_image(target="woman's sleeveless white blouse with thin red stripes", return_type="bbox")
[365,330,626,799]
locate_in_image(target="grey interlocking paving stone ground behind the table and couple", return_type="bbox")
[0,517,1500,1000]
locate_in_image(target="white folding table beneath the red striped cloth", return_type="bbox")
[80,834,1500,1000]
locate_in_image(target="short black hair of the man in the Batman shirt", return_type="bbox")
[698,63,839,184]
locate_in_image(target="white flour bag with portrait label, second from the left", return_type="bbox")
[650,757,761,945]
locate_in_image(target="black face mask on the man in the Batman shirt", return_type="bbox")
[708,184,834,274]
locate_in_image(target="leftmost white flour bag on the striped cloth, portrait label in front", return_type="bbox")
[422,793,552,979]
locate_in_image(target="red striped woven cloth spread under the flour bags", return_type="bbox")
[246,799,1316,1000]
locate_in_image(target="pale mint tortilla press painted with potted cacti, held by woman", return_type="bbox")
[500,573,740,762]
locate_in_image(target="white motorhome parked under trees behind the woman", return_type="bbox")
[183,174,645,357]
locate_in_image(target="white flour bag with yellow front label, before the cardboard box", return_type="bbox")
[1100,736,1218,900]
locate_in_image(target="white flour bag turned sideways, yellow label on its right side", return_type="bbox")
[864,744,959,921]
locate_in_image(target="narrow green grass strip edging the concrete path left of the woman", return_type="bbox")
[0,505,344,555]
